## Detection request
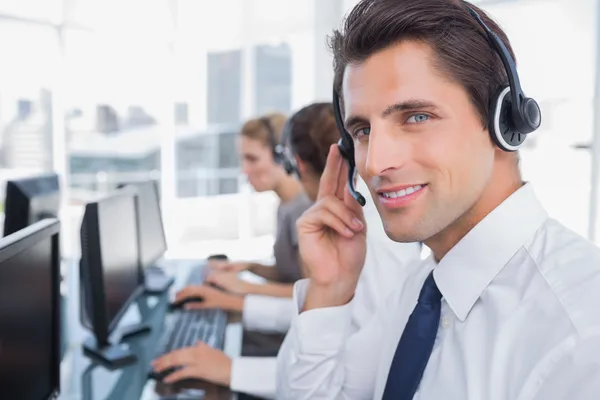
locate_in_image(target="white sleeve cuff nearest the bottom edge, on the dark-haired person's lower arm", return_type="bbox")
[229,357,277,399]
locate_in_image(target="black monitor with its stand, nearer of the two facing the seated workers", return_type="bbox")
[79,189,149,368]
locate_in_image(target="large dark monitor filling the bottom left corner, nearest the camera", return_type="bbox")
[0,219,61,400]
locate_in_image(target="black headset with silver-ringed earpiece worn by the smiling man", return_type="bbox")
[333,7,542,206]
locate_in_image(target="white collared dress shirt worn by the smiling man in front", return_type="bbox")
[277,184,600,400]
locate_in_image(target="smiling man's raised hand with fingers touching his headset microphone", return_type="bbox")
[296,145,367,310]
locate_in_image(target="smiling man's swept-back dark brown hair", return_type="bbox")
[329,0,516,126]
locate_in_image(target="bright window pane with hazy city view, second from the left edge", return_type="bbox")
[65,30,164,208]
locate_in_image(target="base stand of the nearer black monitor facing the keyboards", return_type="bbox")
[83,324,151,369]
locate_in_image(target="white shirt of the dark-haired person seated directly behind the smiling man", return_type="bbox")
[230,180,420,399]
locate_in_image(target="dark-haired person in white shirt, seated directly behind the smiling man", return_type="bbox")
[153,103,420,398]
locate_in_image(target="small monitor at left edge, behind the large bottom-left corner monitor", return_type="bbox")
[4,173,60,236]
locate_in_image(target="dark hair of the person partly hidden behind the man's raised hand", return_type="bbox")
[284,103,340,175]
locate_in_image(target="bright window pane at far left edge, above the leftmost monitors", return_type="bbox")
[0,20,59,214]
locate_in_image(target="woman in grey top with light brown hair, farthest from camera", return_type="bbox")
[202,114,312,297]
